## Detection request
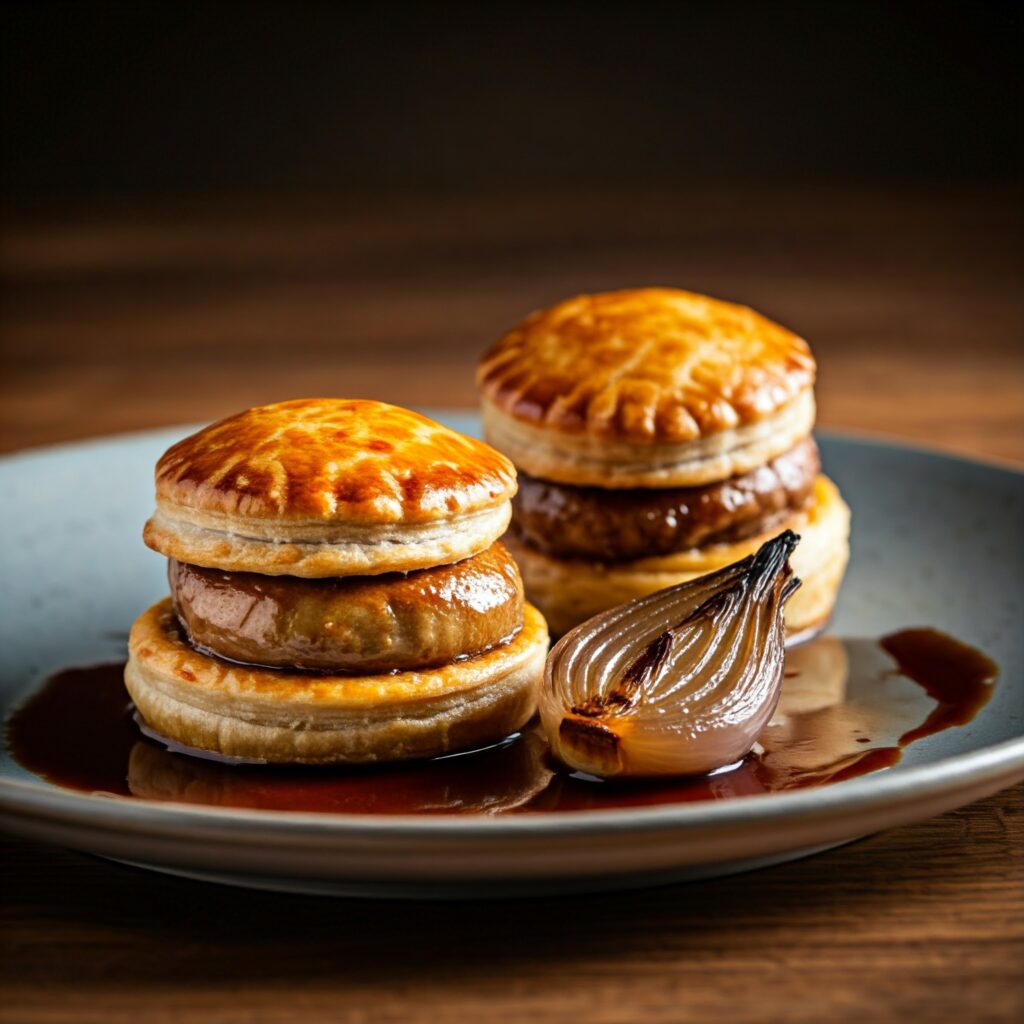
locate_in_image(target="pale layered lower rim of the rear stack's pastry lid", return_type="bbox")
[481,387,815,489]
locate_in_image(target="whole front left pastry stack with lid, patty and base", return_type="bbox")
[125,399,548,764]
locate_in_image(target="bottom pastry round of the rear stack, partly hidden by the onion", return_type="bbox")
[503,475,850,639]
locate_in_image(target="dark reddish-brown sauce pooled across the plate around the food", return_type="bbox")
[7,629,997,814]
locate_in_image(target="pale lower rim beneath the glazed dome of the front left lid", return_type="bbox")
[142,501,512,579]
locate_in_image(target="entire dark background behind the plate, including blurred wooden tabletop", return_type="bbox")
[0,0,1024,458]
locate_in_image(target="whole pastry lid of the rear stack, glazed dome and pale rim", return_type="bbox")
[477,288,815,488]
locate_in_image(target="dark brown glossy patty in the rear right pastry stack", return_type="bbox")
[512,437,820,561]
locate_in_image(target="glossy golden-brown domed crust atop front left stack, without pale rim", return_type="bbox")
[149,398,516,525]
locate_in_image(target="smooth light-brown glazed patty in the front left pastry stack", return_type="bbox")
[168,544,523,675]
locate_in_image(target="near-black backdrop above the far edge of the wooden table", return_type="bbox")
[3,0,1024,210]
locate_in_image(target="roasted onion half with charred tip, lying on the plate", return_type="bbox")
[541,530,800,777]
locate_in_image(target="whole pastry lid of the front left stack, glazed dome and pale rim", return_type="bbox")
[143,398,516,578]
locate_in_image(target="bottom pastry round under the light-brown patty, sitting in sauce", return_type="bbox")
[125,598,548,764]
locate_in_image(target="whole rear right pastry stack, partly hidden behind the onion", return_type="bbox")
[477,288,849,636]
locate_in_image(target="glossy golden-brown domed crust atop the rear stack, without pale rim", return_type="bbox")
[477,288,815,444]
